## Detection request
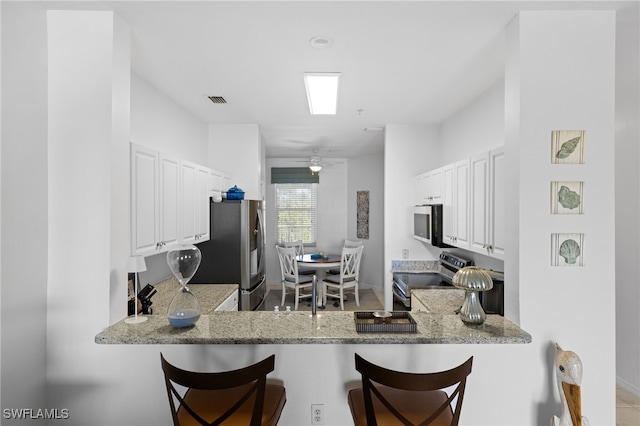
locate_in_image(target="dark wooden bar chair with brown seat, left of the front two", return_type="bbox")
[160,353,287,426]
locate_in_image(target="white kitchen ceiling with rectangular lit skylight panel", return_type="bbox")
[43,0,632,157]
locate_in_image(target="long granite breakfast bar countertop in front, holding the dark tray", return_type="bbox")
[95,311,531,345]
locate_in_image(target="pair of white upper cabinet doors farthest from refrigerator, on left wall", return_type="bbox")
[131,144,180,256]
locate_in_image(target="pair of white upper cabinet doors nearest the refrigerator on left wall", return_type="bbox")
[180,160,210,244]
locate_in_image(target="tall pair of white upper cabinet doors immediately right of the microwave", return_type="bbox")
[442,159,470,249]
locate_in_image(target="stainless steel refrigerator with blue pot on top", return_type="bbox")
[190,199,266,311]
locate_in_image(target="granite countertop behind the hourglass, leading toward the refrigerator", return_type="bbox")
[151,277,238,317]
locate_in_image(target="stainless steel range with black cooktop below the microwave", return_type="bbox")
[393,252,473,310]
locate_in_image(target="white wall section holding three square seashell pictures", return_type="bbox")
[505,12,615,425]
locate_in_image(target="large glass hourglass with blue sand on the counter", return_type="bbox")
[167,245,202,327]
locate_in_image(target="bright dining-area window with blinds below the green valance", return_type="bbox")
[275,183,318,244]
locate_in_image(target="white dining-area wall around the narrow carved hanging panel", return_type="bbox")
[346,154,385,291]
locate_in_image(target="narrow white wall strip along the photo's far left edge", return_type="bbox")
[0,2,48,408]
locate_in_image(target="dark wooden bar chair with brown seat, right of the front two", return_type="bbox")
[347,353,473,426]
